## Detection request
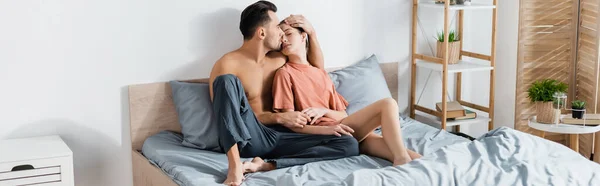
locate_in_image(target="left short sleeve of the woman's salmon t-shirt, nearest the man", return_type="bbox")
[273,69,295,110]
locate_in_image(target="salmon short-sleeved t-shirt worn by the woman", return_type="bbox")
[273,62,348,111]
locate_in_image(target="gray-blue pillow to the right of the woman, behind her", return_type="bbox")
[329,55,392,115]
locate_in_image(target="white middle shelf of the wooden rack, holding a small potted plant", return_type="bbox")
[417,60,494,73]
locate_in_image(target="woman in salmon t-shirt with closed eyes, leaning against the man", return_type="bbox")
[273,22,421,166]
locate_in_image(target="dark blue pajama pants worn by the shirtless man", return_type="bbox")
[213,74,359,168]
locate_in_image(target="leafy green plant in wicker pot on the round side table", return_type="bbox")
[527,79,567,124]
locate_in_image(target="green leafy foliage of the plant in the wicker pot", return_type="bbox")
[527,79,568,102]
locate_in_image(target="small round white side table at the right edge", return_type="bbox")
[528,115,600,155]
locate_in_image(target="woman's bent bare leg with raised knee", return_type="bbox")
[342,98,412,166]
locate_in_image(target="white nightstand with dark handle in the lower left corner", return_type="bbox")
[0,136,74,186]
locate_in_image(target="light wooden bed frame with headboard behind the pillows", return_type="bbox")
[129,62,398,186]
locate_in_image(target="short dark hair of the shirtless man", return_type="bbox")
[240,1,277,40]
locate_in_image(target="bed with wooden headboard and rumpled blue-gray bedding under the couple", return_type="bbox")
[129,63,600,186]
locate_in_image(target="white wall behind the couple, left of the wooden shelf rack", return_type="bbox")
[0,0,412,186]
